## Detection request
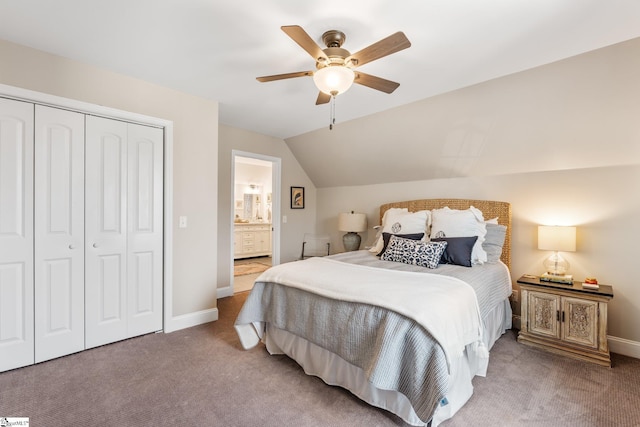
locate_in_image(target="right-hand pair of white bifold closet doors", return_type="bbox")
[85,116,163,348]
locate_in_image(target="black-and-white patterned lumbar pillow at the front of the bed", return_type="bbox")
[380,235,447,268]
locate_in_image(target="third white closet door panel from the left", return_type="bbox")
[85,116,128,348]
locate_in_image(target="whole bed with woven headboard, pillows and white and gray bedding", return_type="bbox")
[235,199,511,426]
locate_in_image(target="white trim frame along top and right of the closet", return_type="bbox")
[0,84,178,332]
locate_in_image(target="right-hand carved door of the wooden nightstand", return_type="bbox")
[562,297,598,349]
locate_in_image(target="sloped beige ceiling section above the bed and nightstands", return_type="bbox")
[286,38,640,188]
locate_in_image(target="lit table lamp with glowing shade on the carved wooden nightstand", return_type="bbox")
[538,225,576,278]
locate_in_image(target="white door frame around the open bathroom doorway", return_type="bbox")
[230,150,282,292]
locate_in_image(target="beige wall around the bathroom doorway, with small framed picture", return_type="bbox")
[218,125,317,288]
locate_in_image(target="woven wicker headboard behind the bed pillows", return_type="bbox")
[380,199,511,269]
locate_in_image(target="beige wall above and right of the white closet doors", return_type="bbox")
[0,40,218,316]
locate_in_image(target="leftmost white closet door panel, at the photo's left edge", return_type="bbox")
[0,98,34,371]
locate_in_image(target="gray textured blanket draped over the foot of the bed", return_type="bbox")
[236,282,448,423]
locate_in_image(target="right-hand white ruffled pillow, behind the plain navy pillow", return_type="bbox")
[431,206,487,264]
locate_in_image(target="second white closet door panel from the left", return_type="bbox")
[34,105,85,363]
